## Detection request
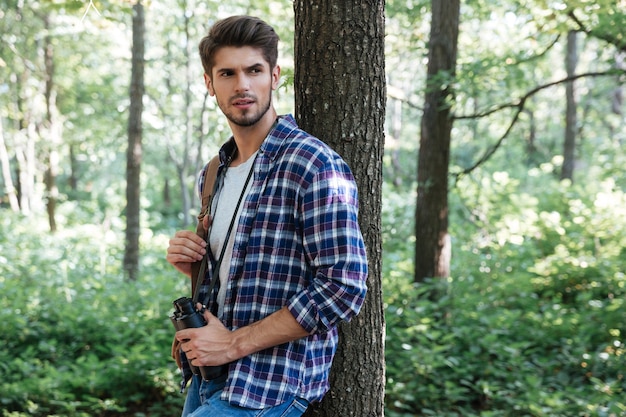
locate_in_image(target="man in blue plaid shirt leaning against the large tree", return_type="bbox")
[167,16,367,417]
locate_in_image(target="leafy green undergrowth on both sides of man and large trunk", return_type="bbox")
[0,170,626,417]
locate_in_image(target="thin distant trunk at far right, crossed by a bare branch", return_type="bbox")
[561,30,578,181]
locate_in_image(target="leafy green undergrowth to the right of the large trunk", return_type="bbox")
[385,167,626,417]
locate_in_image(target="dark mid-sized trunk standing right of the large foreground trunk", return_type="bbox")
[415,0,460,282]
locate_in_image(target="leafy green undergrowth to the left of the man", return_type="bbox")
[0,213,186,417]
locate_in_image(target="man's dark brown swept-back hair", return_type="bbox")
[198,16,278,76]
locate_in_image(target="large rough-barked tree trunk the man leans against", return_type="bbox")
[294,0,385,417]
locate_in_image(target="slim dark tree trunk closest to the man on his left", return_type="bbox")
[124,0,145,281]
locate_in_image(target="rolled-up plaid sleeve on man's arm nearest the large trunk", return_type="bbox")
[288,159,368,333]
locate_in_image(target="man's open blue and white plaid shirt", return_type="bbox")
[179,115,367,409]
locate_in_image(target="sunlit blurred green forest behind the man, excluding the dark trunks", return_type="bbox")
[0,0,626,417]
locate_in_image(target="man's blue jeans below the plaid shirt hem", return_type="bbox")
[182,375,309,417]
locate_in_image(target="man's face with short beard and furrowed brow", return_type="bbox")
[204,46,280,127]
